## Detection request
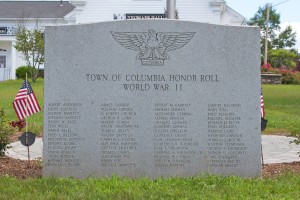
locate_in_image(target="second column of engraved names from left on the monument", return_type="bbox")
[98,103,139,168]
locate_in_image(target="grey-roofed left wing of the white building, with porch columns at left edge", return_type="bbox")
[0,1,75,81]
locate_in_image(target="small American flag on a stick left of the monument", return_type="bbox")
[13,80,41,120]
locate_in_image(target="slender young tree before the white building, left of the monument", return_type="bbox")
[14,27,45,82]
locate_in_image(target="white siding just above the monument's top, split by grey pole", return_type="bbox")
[71,0,236,24]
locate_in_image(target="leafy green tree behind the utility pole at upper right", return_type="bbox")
[247,5,296,55]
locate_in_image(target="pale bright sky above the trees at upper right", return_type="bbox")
[226,0,300,50]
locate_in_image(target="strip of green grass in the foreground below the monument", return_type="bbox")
[0,174,300,200]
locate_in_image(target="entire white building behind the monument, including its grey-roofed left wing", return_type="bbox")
[0,0,244,81]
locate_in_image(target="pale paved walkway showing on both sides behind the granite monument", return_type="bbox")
[6,135,300,164]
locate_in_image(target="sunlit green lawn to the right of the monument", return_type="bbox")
[263,85,300,134]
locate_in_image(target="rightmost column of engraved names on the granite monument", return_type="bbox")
[207,103,247,167]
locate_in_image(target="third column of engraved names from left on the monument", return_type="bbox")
[153,103,198,168]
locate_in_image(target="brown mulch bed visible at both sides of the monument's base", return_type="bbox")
[0,156,300,179]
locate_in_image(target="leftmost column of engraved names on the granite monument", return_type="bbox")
[45,103,85,167]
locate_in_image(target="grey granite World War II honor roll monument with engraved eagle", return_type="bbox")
[43,20,261,178]
